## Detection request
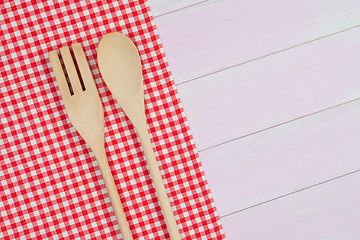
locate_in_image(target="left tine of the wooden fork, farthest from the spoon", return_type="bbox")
[49,50,71,98]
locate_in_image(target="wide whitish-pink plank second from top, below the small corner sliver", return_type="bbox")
[153,0,360,83]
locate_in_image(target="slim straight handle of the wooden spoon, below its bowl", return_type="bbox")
[136,124,181,240]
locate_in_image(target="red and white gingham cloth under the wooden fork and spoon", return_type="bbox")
[0,0,225,239]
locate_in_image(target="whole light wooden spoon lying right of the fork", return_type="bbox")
[97,32,180,240]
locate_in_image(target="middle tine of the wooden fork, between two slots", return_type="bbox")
[60,46,82,94]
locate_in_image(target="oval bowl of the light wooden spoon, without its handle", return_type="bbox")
[98,32,144,121]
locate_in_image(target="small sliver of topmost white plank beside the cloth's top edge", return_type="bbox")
[149,0,206,17]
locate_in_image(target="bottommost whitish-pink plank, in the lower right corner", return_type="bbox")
[222,173,360,240]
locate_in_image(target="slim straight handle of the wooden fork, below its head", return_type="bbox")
[95,151,133,240]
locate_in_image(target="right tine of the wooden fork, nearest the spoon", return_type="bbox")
[71,43,96,90]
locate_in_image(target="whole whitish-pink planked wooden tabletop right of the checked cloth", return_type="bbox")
[149,0,360,240]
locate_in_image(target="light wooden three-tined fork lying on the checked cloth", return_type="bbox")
[49,43,133,240]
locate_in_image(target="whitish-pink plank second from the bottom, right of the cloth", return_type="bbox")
[200,100,360,217]
